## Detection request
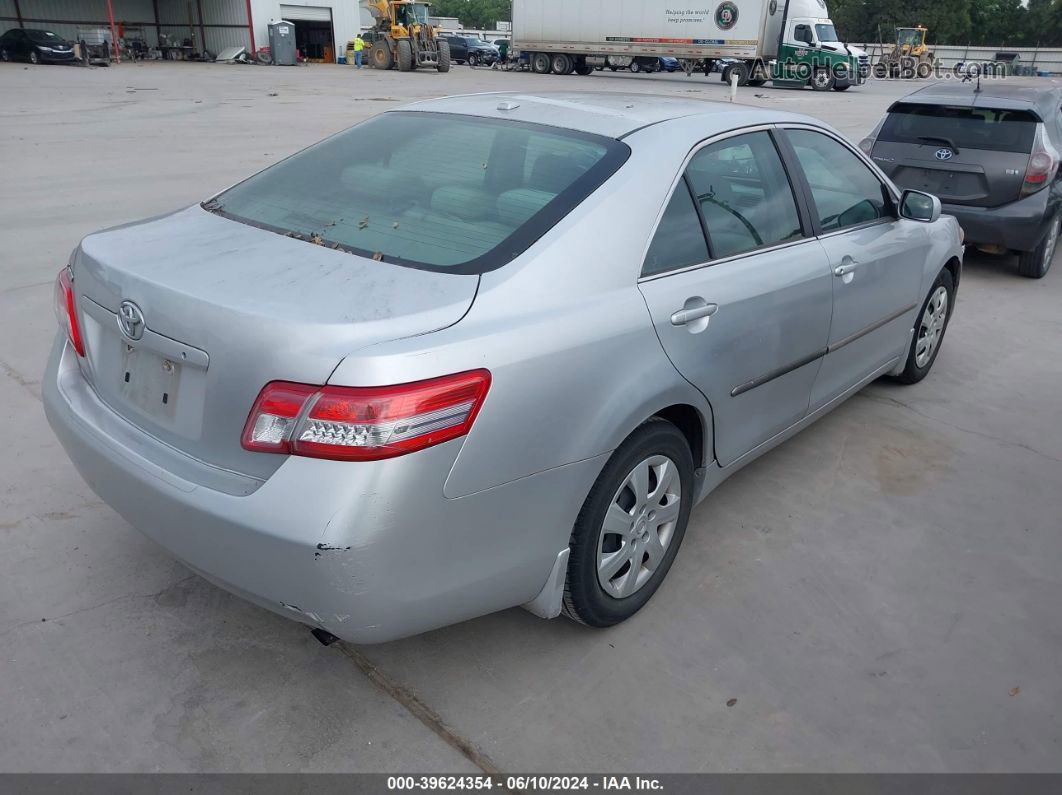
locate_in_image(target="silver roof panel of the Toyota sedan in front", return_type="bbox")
[395,91,826,138]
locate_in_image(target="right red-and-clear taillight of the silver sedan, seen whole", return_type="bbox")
[243,369,491,461]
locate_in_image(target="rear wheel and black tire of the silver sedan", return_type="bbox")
[563,418,693,627]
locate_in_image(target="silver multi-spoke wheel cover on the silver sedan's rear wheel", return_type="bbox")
[597,455,682,599]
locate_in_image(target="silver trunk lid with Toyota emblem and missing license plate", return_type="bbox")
[73,206,478,478]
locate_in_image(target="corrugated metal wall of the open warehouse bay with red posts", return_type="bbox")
[0,0,251,54]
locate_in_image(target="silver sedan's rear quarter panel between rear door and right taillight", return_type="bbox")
[331,136,712,498]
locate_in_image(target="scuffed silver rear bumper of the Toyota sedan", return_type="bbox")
[44,342,606,643]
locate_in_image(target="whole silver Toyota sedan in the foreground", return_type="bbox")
[44,93,962,642]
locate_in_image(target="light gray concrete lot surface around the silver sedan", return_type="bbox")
[0,63,1062,772]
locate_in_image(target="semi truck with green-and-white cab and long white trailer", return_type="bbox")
[513,0,870,91]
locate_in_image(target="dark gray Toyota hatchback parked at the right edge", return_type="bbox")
[859,81,1062,279]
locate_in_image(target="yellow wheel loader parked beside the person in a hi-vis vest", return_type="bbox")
[365,0,450,72]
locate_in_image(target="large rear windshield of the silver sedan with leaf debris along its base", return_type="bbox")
[203,111,630,273]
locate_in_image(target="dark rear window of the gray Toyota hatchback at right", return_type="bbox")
[878,102,1037,154]
